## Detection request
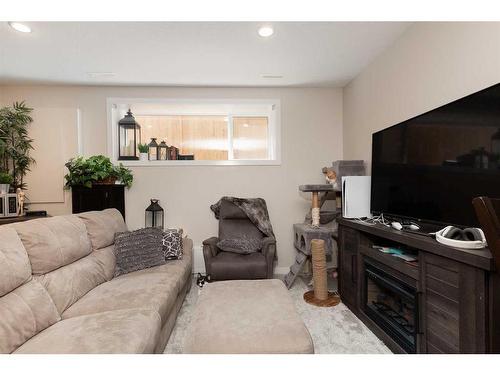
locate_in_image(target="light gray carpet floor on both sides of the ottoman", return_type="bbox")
[165,278,391,354]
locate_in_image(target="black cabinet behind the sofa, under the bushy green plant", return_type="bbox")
[71,185,125,218]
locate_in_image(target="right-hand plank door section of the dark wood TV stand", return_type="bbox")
[420,253,487,353]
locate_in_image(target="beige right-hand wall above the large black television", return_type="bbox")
[343,23,500,170]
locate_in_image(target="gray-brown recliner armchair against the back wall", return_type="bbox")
[203,200,276,280]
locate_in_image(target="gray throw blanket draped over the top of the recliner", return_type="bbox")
[210,197,274,238]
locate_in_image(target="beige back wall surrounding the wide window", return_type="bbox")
[0,86,342,267]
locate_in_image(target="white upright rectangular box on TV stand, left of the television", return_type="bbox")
[342,176,372,219]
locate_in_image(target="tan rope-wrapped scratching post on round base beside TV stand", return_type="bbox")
[304,239,340,307]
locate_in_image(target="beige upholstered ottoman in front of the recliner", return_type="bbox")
[184,279,314,354]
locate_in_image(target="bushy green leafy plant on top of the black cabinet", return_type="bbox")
[64,155,134,188]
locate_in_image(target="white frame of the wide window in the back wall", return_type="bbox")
[106,97,281,167]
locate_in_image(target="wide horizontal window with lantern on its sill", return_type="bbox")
[108,98,280,166]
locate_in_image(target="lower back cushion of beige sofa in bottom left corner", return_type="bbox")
[0,280,61,353]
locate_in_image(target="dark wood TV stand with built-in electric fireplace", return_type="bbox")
[339,219,500,353]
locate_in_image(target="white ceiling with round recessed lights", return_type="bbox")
[0,22,410,87]
